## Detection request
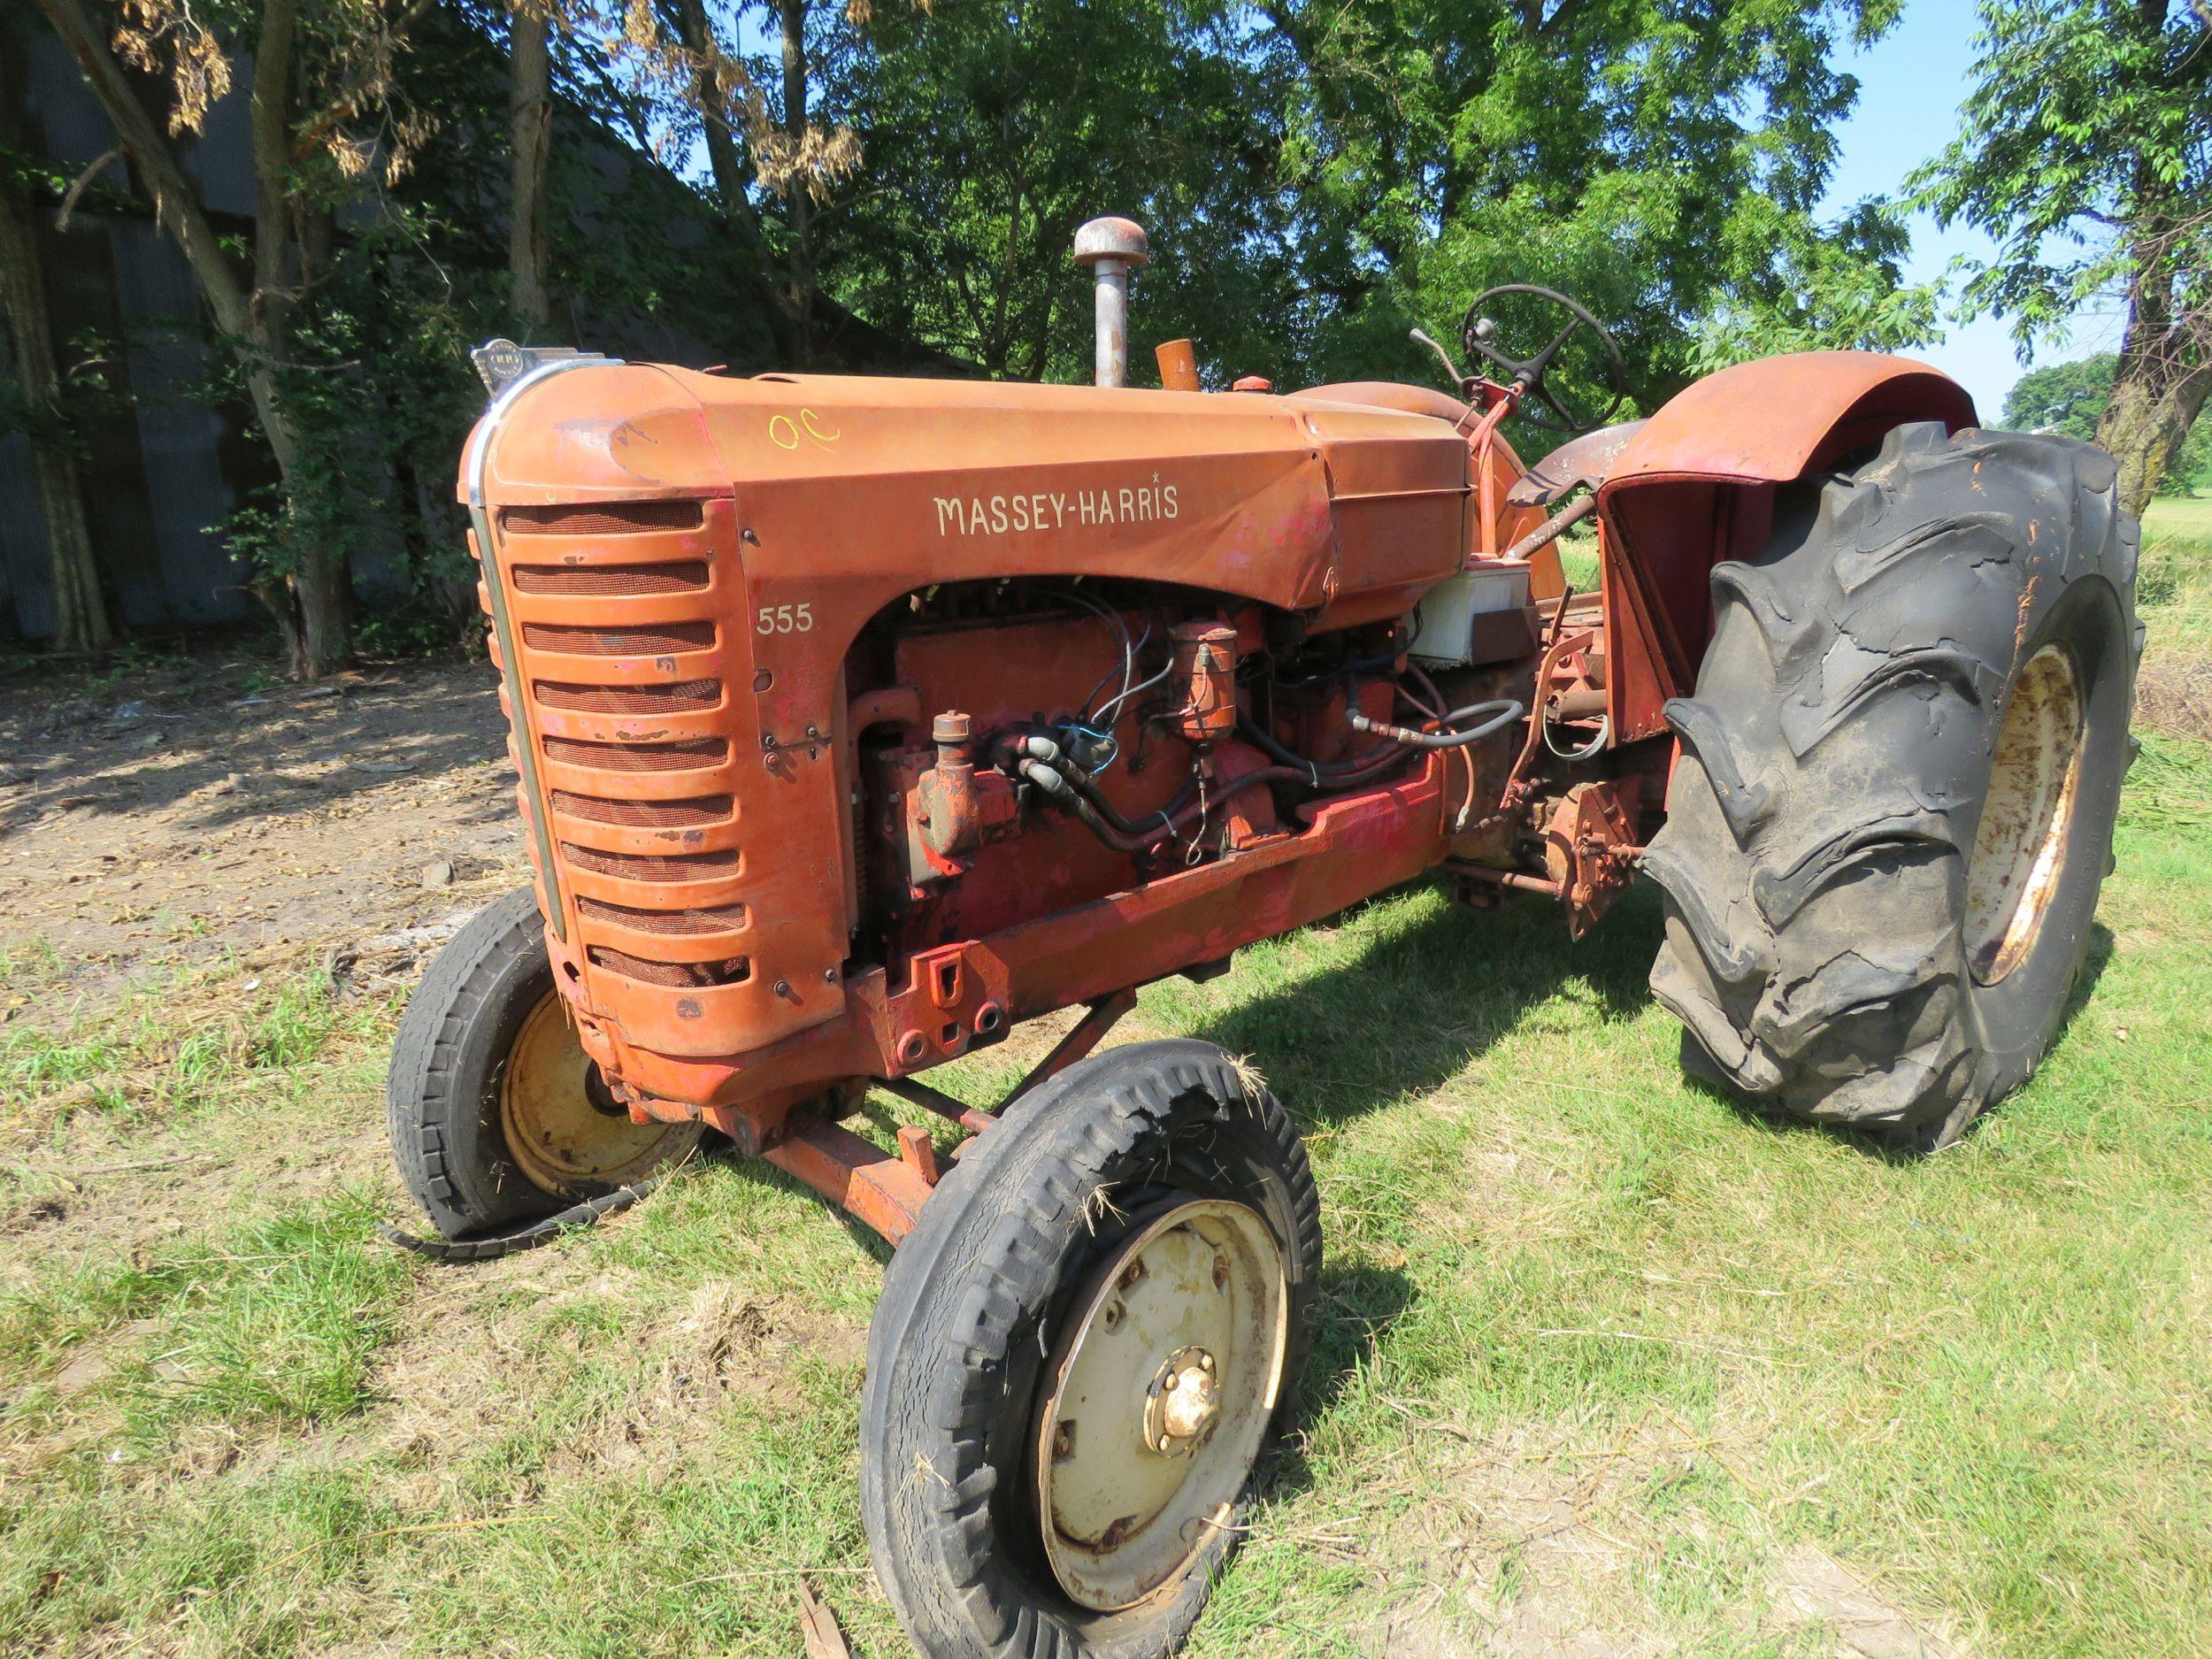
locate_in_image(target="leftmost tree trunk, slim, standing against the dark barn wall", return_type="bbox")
[0,35,113,650]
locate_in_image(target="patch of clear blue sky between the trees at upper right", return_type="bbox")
[1827,0,2119,420]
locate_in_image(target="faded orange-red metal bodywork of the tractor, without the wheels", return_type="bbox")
[457,345,1962,1241]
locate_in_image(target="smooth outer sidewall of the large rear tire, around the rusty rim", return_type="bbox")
[1967,578,2135,1100]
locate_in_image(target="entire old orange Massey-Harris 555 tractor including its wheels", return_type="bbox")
[392,219,2141,1659]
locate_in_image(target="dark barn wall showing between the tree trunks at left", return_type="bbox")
[0,29,772,640]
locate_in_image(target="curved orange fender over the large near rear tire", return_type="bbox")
[1597,352,1973,743]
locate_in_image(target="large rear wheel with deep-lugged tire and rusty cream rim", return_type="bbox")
[1644,425,2141,1150]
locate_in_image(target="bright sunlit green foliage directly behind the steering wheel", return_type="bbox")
[1259,0,1936,405]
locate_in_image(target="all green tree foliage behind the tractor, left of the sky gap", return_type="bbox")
[25,0,1973,650]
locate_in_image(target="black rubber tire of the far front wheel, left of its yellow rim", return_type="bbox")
[385,887,571,1239]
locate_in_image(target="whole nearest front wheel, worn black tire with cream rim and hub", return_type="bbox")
[861,1042,1321,1659]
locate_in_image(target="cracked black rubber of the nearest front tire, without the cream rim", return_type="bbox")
[861,1042,1321,1659]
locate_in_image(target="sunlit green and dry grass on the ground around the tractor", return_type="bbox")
[0,597,2212,1659]
